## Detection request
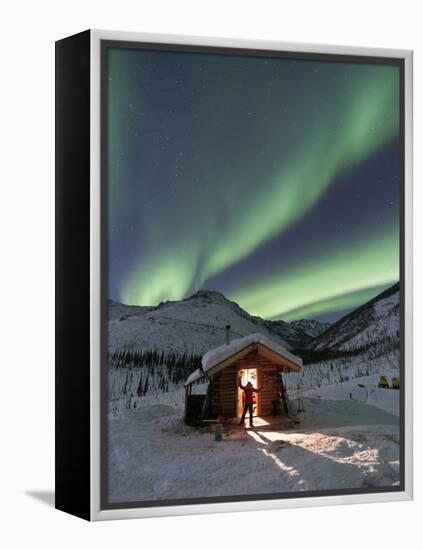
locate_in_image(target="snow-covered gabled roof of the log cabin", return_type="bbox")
[201,333,303,376]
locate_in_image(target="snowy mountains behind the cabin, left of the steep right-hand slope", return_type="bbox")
[109,290,329,355]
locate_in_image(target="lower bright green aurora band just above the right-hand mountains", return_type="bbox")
[233,222,399,321]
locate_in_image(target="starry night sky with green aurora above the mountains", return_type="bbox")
[107,48,400,321]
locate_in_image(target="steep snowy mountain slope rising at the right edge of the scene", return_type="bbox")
[311,283,400,350]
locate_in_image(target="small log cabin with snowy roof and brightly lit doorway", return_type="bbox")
[185,333,302,425]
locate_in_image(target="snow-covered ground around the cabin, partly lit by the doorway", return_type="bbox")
[109,377,399,502]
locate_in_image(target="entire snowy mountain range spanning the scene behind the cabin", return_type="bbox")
[108,283,399,355]
